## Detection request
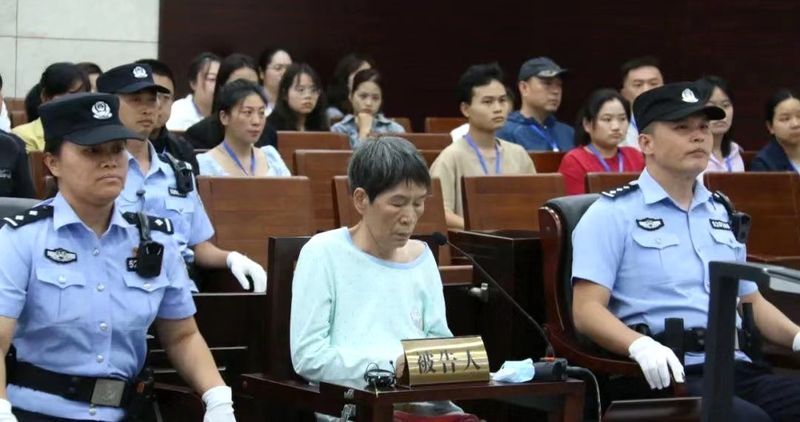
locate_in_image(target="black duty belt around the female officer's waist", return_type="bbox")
[8,361,134,407]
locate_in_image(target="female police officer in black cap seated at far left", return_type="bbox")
[0,93,234,422]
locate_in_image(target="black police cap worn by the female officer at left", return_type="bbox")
[39,92,142,146]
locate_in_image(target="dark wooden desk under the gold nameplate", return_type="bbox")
[241,374,585,422]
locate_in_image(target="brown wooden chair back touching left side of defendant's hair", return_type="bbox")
[294,149,353,231]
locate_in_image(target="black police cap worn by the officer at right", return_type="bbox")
[633,82,725,130]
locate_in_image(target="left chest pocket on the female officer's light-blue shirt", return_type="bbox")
[34,267,89,324]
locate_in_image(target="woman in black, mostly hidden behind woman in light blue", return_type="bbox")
[184,53,278,149]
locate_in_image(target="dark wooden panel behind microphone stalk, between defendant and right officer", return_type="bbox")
[448,230,544,371]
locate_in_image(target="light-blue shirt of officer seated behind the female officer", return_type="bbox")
[118,142,214,263]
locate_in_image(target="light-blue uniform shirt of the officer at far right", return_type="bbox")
[572,169,757,365]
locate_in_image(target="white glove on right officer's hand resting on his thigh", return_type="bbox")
[628,336,684,390]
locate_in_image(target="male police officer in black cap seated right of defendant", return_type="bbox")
[572,82,800,421]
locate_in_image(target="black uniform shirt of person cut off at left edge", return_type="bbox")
[0,132,36,198]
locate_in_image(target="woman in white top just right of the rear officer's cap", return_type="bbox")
[167,52,220,131]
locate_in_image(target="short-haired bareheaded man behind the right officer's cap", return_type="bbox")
[619,56,664,148]
